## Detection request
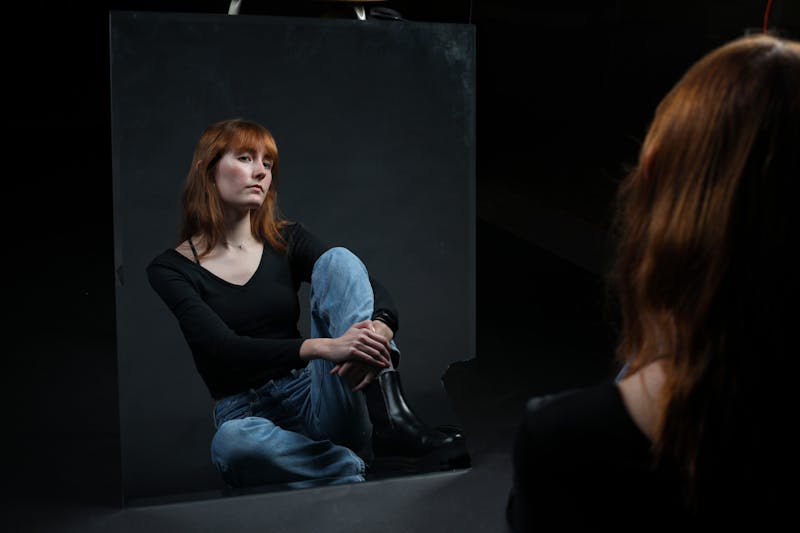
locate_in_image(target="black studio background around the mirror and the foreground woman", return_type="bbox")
[2,0,800,531]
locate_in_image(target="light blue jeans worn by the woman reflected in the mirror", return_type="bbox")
[211,247,397,487]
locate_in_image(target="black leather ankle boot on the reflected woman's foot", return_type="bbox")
[364,370,469,468]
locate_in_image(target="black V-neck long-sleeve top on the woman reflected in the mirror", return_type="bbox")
[147,223,398,399]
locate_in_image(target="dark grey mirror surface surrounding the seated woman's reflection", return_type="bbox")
[109,12,475,504]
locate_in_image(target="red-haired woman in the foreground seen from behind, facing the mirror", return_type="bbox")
[507,35,800,531]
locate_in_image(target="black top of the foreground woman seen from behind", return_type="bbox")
[505,380,797,533]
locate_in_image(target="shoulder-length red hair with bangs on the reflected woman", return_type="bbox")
[180,118,288,257]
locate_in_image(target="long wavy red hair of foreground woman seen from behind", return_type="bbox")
[614,35,800,512]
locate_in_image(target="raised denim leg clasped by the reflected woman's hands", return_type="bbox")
[309,247,397,457]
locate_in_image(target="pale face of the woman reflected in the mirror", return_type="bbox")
[214,150,272,211]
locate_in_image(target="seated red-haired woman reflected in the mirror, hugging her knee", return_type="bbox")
[147,119,463,486]
